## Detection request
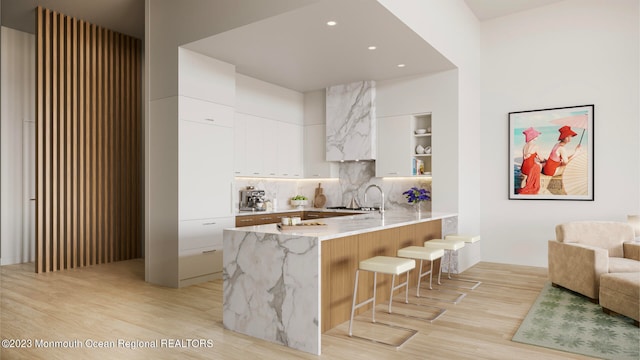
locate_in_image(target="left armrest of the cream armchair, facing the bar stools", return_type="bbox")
[548,240,609,299]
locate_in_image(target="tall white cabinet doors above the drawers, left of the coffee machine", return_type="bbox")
[178,49,235,221]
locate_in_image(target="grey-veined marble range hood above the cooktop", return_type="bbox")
[326,81,377,161]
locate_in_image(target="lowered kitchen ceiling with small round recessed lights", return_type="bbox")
[185,0,455,92]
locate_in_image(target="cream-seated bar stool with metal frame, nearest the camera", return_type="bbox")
[349,256,418,348]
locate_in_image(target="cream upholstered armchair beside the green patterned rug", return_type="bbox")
[548,221,640,301]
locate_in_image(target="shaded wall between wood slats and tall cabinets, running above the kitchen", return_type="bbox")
[144,0,312,286]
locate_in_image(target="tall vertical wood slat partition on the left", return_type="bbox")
[36,7,142,272]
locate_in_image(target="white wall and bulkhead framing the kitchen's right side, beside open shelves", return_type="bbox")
[378,0,484,239]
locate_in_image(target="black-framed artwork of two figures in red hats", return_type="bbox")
[509,105,594,201]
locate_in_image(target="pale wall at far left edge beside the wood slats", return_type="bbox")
[0,27,35,265]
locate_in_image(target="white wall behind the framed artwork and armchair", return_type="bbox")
[478,0,640,267]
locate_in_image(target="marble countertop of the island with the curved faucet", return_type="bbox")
[226,210,457,241]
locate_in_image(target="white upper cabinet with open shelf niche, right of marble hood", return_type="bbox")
[376,114,431,177]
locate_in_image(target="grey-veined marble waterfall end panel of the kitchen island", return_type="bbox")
[223,230,320,355]
